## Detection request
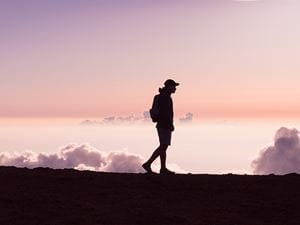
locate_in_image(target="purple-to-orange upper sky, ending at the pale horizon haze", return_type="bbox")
[0,0,300,118]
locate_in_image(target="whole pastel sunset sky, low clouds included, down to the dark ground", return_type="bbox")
[0,0,300,174]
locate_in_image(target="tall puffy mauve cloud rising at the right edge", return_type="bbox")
[252,127,300,175]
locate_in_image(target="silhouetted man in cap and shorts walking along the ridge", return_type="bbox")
[142,79,179,174]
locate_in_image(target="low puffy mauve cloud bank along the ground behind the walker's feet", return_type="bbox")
[0,143,184,173]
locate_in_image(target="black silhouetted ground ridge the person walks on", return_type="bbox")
[0,167,300,225]
